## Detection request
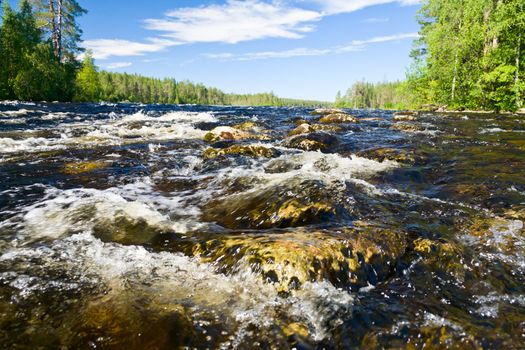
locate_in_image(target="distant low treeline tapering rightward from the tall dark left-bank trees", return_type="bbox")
[77,52,328,106]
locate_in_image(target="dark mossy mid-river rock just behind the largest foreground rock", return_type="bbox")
[203,181,349,229]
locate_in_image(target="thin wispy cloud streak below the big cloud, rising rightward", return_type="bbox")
[204,33,419,61]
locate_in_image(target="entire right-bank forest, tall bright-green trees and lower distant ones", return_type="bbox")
[336,0,525,111]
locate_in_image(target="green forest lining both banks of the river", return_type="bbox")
[0,0,525,111]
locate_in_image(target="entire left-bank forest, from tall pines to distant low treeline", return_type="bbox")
[0,0,326,106]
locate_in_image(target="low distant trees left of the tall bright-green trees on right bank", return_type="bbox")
[335,80,414,109]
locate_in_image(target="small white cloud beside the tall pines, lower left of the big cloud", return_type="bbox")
[83,38,179,60]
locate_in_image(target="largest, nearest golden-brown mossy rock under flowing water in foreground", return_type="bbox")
[184,226,406,292]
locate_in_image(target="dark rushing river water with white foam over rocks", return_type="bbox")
[0,103,525,349]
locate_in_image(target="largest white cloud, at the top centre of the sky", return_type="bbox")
[145,0,322,44]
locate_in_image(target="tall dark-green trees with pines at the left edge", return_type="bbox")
[0,0,85,101]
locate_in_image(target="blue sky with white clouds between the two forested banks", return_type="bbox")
[14,0,419,101]
